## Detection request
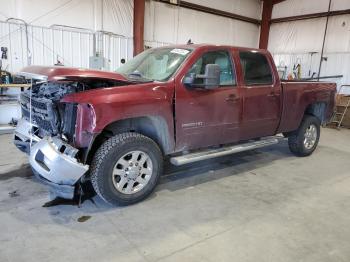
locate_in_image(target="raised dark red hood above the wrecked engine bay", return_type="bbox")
[17,66,130,82]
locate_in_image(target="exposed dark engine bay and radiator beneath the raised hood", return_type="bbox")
[20,79,131,142]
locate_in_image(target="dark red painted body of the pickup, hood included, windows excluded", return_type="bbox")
[22,45,336,153]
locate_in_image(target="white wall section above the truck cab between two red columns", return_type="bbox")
[145,0,261,47]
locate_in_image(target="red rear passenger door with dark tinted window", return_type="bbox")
[238,51,281,140]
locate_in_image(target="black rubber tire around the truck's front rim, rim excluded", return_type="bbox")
[90,132,163,205]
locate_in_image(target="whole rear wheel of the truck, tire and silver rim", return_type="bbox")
[288,115,321,156]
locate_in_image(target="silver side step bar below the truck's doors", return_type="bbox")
[170,137,279,166]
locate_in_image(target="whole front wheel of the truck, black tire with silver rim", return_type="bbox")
[91,133,163,205]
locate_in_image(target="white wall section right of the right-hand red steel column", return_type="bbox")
[268,0,350,92]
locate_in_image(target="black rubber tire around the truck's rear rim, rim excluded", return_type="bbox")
[288,115,321,157]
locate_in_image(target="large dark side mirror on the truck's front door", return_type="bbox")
[183,64,220,90]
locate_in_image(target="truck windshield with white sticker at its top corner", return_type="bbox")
[116,48,191,81]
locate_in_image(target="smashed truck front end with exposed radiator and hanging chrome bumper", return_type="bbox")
[14,82,89,199]
